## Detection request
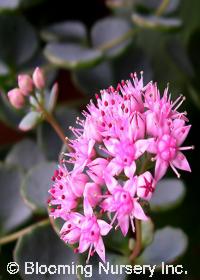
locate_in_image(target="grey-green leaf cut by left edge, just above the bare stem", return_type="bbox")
[0,164,31,234]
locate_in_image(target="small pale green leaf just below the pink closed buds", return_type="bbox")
[19,112,42,131]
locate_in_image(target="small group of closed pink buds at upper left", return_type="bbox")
[8,67,45,109]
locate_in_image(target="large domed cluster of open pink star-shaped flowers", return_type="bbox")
[48,74,193,261]
